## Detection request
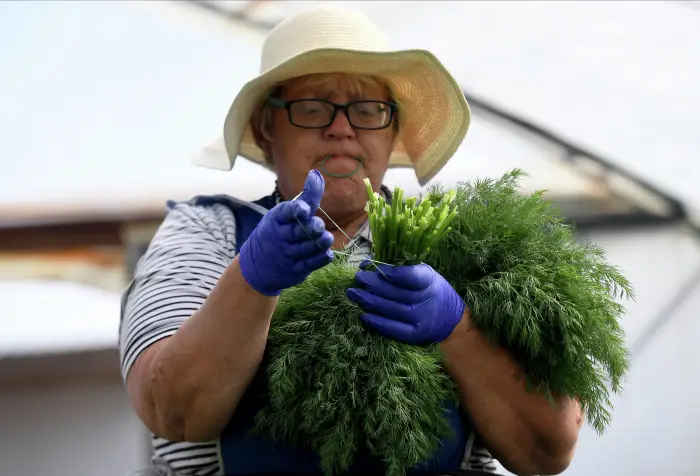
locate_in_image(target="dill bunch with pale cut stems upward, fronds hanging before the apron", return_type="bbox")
[256,180,458,476]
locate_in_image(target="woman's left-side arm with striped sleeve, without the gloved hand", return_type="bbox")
[120,204,276,442]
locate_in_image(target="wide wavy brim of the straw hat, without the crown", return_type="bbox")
[193,49,471,186]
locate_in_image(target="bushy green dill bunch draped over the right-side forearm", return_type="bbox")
[425,170,633,433]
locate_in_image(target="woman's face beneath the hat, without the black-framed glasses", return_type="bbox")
[261,74,396,219]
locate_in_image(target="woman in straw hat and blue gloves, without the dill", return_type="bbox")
[120,8,582,475]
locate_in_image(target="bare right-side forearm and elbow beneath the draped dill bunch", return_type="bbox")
[441,314,582,475]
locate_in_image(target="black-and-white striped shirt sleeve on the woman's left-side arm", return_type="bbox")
[119,203,236,381]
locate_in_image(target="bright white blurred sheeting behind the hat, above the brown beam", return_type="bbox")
[0,2,700,215]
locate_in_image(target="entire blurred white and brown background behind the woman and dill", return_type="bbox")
[0,0,700,476]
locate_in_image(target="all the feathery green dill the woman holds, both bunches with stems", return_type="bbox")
[256,170,632,476]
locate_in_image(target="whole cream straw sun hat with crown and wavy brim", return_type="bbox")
[193,6,470,186]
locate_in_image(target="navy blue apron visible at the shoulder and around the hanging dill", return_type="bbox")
[190,195,471,476]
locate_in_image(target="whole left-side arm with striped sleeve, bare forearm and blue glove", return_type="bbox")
[120,180,333,442]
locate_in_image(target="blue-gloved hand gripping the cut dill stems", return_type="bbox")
[347,262,466,344]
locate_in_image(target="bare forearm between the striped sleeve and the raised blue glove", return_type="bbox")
[131,259,277,441]
